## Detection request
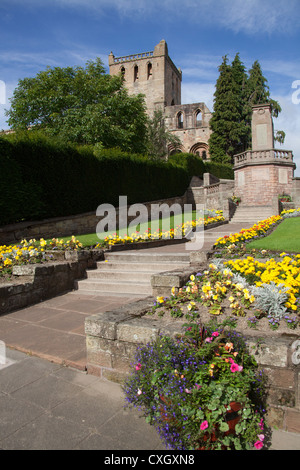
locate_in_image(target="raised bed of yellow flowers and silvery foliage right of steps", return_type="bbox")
[149,256,300,332]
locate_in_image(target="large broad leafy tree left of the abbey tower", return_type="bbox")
[6,58,147,153]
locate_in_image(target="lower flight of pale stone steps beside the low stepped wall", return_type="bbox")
[77,250,190,297]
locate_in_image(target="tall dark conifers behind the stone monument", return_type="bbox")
[209,54,284,163]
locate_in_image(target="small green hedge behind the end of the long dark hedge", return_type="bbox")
[168,153,234,179]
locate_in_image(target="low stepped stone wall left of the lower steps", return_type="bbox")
[0,250,104,315]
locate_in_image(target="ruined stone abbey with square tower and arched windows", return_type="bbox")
[108,40,211,159]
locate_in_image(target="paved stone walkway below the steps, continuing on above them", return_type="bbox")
[0,224,300,450]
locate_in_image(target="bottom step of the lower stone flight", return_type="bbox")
[76,279,152,295]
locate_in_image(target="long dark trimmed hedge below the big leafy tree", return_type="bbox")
[0,132,190,225]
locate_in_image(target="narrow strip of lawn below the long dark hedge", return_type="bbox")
[48,211,196,246]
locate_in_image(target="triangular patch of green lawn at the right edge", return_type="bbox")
[247,217,300,253]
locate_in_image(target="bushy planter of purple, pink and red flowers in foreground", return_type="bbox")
[124,322,266,450]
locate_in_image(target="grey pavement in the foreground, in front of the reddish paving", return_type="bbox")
[0,349,300,454]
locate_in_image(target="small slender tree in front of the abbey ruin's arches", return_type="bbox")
[147,110,181,159]
